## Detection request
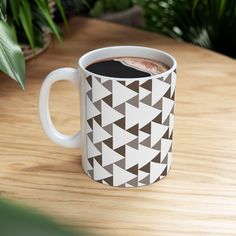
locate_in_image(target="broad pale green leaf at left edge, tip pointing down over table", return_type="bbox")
[0,21,25,89]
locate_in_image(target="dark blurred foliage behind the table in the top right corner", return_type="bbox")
[136,0,236,58]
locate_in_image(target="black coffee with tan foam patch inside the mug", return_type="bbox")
[86,57,169,78]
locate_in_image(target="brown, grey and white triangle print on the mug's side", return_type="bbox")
[85,71,176,187]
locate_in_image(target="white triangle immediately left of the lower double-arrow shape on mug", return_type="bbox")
[102,143,124,166]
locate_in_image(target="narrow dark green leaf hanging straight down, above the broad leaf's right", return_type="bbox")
[19,0,35,49]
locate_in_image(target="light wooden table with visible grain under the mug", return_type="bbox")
[0,18,236,236]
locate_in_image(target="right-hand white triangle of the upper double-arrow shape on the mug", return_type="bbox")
[139,102,161,128]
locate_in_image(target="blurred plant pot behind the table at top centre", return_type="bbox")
[90,0,143,27]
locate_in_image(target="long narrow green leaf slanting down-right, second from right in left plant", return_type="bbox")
[35,0,61,42]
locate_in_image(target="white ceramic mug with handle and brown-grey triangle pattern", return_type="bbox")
[39,46,176,187]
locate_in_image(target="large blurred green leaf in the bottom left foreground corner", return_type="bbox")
[0,200,91,236]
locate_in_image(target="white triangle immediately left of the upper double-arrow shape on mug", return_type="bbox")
[101,101,124,127]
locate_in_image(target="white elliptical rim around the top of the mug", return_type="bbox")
[78,45,177,81]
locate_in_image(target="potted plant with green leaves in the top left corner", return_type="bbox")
[0,0,67,89]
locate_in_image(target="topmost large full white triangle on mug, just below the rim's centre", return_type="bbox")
[112,80,137,107]
